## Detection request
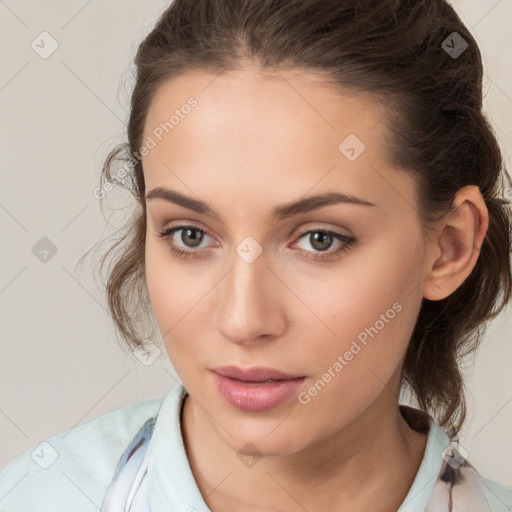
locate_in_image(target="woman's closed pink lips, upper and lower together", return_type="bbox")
[211,366,306,412]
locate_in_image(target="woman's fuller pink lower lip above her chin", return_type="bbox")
[212,372,305,412]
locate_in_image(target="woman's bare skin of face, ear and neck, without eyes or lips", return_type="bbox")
[143,65,488,512]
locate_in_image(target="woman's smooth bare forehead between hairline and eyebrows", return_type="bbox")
[143,69,412,218]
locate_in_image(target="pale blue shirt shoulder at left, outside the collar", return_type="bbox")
[0,398,163,512]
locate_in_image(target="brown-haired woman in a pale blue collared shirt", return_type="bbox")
[0,0,512,512]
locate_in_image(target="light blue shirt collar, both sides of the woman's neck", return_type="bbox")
[101,383,491,512]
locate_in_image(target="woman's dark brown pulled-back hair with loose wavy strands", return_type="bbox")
[93,0,512,437]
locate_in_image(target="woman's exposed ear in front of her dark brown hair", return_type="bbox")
[423,185,489,300]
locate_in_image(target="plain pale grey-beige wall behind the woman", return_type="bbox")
[0,0,512,488]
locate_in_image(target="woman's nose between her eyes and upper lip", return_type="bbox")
[216,249,287,345]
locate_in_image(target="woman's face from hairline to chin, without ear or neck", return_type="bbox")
[143,63,427,454]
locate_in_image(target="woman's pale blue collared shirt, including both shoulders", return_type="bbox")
[0,383,512,512]
